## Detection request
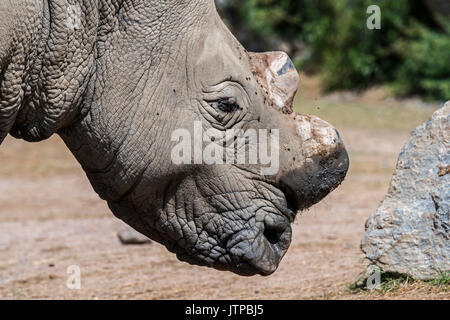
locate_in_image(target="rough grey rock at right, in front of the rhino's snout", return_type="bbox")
[361,102,450,280]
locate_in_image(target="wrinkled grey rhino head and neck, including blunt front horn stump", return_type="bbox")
[0,0,348,276]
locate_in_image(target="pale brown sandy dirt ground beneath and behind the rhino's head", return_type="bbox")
[0,92,450,299]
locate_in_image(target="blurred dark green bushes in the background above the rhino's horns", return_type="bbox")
[216,0,450,100]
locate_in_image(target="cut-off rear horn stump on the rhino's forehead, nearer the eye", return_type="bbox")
[249,51,300,113]
